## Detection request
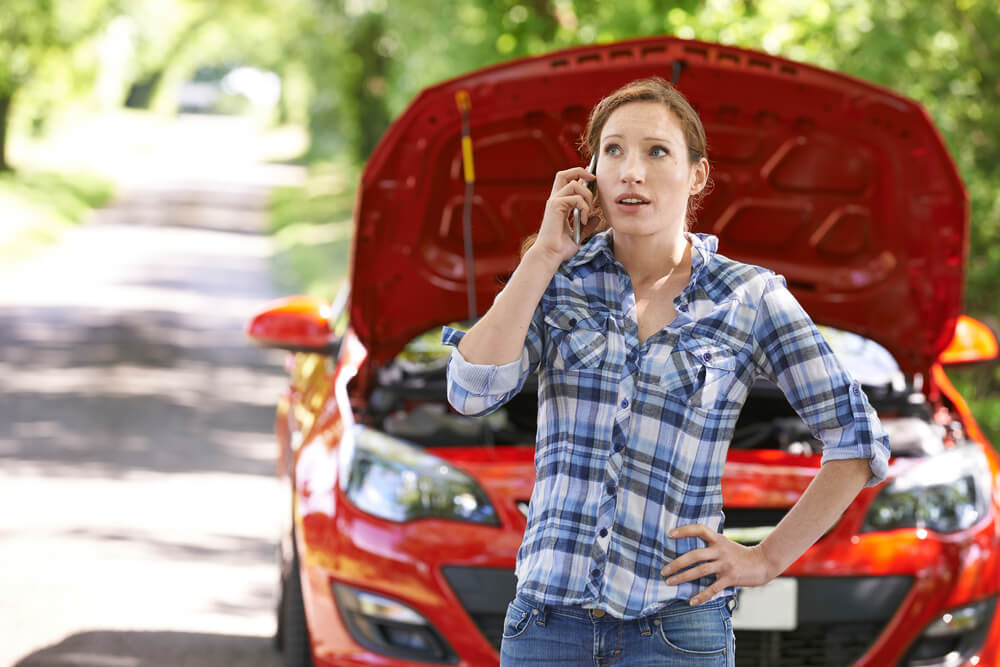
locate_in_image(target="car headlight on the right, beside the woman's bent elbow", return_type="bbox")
[862,445,991,533]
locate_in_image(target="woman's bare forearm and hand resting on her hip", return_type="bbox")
[662,459,871,604]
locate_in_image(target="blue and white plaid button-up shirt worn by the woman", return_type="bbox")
[442,231,889,619]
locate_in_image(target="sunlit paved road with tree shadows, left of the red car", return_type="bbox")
[0,119,304,667]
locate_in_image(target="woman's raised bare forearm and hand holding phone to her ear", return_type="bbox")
[458,167,596,365]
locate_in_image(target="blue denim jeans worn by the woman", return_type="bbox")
[500,595,736,667]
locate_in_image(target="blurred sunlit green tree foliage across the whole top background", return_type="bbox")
[7,0,1000,430]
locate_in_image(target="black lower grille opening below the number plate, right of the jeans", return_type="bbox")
[735,623,884,667]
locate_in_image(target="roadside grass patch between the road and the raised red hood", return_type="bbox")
[270,162,359,300]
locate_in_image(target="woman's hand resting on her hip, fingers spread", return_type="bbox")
[660,523,775,605]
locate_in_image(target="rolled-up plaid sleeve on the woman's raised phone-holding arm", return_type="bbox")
[441,294,542,415]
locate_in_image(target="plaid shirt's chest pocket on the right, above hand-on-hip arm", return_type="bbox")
[651,339,736,408]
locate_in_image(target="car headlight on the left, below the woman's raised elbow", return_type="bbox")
[340,425,500,526]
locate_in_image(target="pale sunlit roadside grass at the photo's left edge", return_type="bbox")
[0,169,114,264]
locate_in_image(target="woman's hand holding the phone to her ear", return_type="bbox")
[531,167,597,263]
